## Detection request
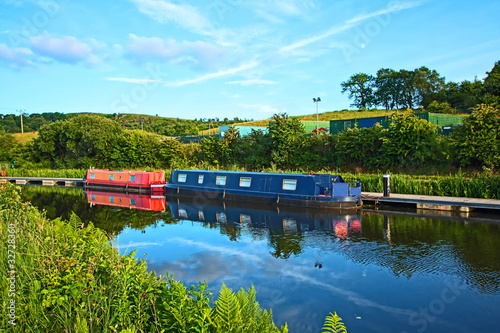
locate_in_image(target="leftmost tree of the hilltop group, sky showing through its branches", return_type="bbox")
[340,73,375,109]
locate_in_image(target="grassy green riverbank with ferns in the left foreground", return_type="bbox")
[0,184,287,332]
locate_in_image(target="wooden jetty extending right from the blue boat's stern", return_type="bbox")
[361,192,500,213]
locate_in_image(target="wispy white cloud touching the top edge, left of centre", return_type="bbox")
[131,0,211,34]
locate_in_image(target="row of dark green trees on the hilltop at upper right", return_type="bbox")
[341,61,500,113]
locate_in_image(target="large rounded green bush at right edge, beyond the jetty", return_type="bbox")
[451,104,500,169]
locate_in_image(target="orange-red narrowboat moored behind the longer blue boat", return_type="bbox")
[83,169,166,193]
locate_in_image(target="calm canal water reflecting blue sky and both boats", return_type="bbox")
[20,187,500,333]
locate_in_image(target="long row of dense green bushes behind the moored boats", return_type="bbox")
[0,104,500,172]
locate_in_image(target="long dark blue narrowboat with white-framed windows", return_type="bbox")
[166,170,363,209]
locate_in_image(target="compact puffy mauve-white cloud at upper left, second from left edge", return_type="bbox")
[30,34,98,64]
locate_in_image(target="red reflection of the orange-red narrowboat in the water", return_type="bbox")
[83,191,165,212]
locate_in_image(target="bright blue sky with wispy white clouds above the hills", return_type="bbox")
[0,0,500,120]
